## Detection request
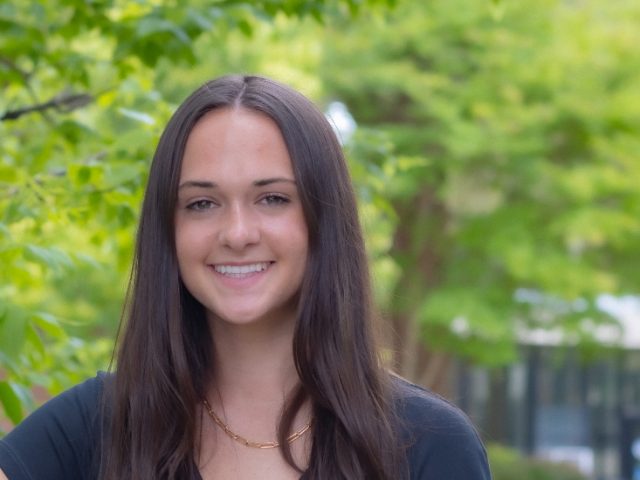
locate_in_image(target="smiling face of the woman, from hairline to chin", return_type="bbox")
[175,108,308,325]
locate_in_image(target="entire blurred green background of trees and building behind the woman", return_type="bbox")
[0,0,640,480]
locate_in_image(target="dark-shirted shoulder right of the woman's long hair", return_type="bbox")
[395,379,491,480]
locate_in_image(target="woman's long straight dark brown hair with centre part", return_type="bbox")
[100,76,404,480]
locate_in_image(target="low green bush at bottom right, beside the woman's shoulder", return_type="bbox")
[487,444,588,480]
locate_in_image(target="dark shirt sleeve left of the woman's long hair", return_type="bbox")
[0,374,104,480]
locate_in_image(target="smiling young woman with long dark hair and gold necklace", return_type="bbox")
[0,76,490,480]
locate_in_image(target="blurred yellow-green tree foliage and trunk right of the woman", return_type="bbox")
[320,0,640,368]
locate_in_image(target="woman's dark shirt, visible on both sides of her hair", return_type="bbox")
[0,373,491,480]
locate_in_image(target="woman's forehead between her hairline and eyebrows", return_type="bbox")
[181,108,293,177]
